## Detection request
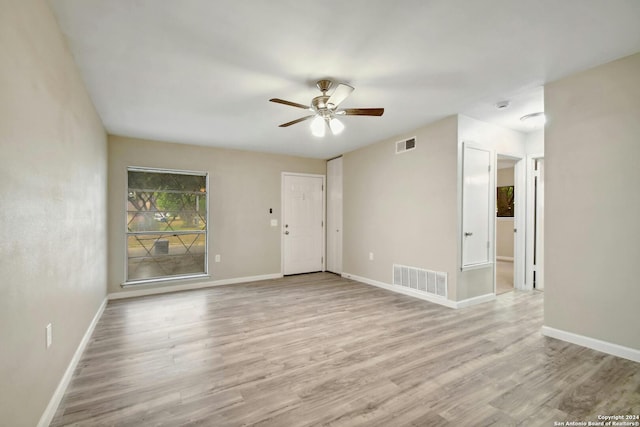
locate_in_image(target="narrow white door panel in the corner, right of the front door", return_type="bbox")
[327,157,342,274]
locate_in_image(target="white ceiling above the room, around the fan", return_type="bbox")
[50,0,640,158]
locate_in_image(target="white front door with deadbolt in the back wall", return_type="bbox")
[282,173,324,274]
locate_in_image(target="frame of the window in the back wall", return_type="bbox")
[121,166,210,288]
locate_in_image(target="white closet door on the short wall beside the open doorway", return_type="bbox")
[462,143,495,268]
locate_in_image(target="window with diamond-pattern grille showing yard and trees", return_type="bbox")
[126,168,207,284]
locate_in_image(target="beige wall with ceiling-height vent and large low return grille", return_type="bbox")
[343,117,457,300]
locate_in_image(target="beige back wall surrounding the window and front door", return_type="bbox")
[108,136,326,293]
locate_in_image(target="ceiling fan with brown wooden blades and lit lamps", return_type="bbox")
[269,80,384,137]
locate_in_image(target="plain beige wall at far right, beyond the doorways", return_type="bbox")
[544,54,640,349]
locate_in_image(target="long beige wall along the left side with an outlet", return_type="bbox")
[0,0,107,427]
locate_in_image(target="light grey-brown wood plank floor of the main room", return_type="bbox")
[52,273,640,427]
